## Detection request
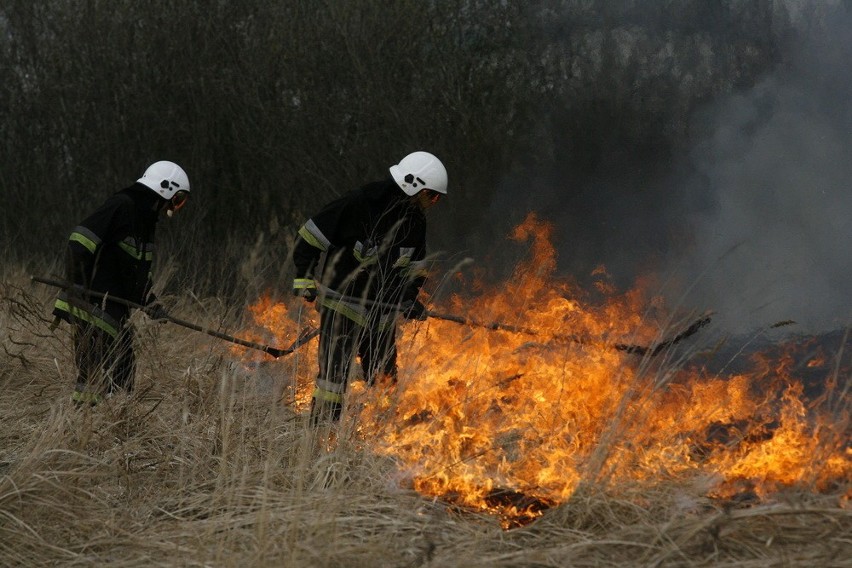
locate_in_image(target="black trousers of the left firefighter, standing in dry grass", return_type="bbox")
[74,320,136,395]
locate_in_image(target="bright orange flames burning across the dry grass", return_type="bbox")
[238,215,852,526]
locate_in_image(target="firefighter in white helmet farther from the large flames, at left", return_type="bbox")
[53,161,189,405]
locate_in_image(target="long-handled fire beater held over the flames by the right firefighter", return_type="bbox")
[312,286,711,357]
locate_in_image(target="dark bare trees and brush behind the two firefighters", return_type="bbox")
[0,0,804,302]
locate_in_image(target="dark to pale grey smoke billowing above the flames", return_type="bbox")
[452,0,852,333]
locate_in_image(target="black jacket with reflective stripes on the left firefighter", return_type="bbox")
[54,183,162,331]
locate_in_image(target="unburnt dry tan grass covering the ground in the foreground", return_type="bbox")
[0,275,852,567]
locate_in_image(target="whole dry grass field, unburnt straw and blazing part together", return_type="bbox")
[0,213,852,567]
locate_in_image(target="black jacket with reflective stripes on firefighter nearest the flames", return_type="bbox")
[293,178,426,320]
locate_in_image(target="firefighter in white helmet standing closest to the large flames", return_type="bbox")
[293,152,447,425]
